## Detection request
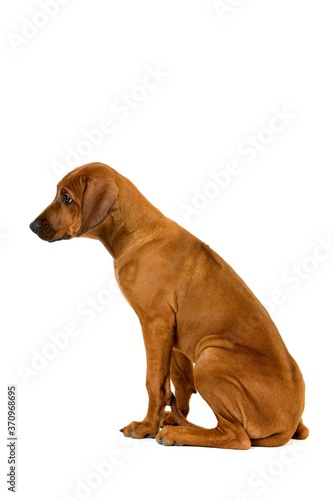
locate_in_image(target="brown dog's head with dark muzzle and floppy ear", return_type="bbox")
[30,163,118,242]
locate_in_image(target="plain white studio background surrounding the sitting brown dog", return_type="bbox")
[0,0,333,500]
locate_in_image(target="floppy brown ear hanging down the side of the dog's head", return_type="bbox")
[76,177,118,236]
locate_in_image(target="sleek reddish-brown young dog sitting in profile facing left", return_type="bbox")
[30,163,309,449]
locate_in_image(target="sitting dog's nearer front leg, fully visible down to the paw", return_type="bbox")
[122,320,173,439]
